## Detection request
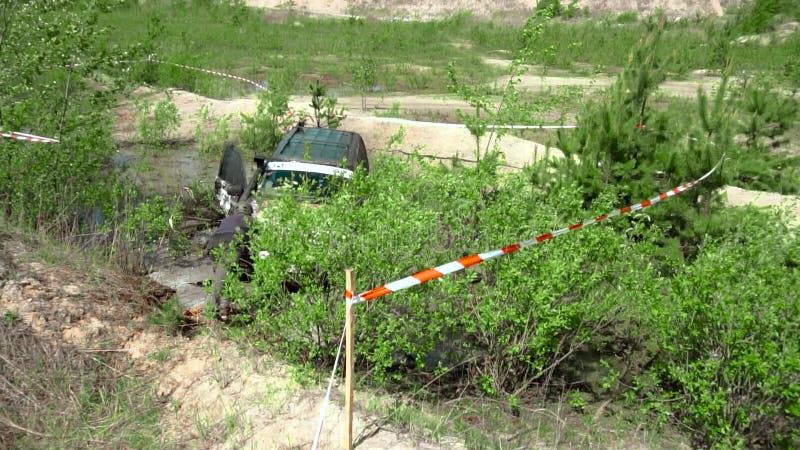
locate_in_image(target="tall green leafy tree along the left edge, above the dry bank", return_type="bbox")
[0,0,123,232]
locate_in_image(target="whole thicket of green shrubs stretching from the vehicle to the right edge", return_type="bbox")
[231,152,800,447]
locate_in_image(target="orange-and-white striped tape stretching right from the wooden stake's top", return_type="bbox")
[349,154,725,304]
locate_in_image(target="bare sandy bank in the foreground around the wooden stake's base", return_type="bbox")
[0,235,460,450]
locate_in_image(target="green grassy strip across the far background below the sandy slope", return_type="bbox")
[101,1,800,95]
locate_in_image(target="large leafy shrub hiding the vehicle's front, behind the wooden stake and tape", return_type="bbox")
[235,159,654,393]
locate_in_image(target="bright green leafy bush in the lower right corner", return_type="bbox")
[658,211,800,448]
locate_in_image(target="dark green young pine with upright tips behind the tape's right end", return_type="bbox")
[556,21,738,256]
